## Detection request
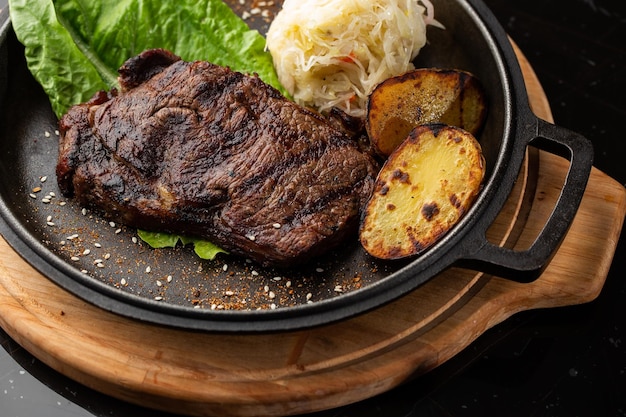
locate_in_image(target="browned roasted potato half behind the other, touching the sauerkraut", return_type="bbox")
[365,68,487,156]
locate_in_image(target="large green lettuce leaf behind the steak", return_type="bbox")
[9,0,285,117]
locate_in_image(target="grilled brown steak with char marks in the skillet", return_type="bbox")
[57,50,376,266]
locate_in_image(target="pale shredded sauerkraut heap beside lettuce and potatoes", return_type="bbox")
[267,0,434,117]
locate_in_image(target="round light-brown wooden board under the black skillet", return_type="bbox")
[0,44,626,416]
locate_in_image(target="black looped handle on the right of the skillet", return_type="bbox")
[465,119,593,282]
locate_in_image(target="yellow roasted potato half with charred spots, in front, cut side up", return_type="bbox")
[359,124,485,259]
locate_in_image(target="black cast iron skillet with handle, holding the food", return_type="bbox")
[0,0,593,332]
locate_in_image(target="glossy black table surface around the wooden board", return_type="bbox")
[0,0,626,417]
